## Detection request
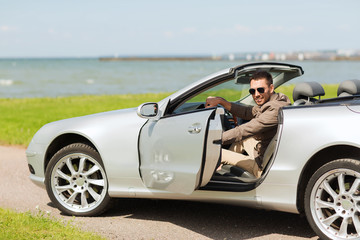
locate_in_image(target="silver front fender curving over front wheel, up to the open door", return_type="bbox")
[26,108,147,192]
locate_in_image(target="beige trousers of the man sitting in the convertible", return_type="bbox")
[221,138,262,178]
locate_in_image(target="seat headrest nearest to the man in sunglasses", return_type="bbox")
[293,82,325,101]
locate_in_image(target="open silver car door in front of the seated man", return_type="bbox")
[139,108,224,194]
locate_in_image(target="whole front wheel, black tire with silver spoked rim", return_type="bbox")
[45,143,111,216]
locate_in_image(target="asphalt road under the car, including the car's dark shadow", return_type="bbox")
[0,146,318,240]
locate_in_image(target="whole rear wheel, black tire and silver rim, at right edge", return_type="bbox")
[305,159,360,239]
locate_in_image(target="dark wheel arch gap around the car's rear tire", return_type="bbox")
[296,145,360,213]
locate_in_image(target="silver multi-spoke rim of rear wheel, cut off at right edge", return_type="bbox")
[310,169,360,239]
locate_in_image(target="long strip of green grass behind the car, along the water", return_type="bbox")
[0,85,337,147]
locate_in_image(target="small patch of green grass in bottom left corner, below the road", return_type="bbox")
[0,208,105,240]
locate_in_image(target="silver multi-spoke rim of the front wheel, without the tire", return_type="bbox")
[51,153,107,212]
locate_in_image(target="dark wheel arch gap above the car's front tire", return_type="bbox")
[44,133,98,172]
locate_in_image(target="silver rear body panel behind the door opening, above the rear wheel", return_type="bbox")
[259,105,360,212]
